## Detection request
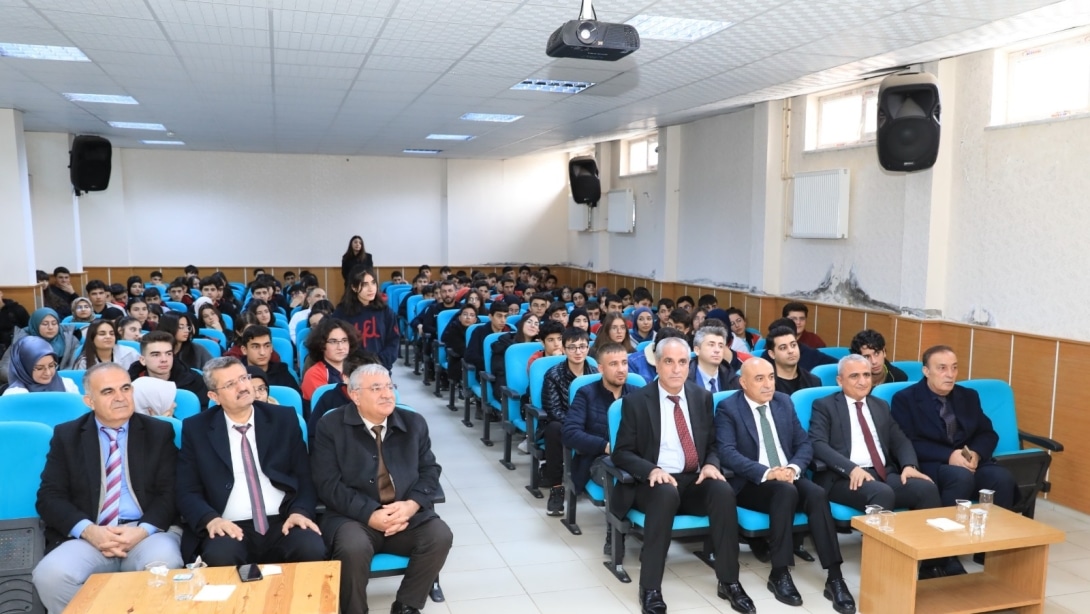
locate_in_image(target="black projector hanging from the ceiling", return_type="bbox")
[545,0,640,62]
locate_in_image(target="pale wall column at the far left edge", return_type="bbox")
[0,109,35,286]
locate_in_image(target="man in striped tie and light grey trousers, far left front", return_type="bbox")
[33,362,182,614]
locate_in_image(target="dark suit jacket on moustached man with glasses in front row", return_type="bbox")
[178,401,315,543]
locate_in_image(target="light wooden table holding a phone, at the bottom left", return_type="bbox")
[64,561,340,614]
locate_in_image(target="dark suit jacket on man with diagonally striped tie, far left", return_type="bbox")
[37,412,178,550]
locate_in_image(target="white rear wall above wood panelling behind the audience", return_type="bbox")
[19,145,567,267]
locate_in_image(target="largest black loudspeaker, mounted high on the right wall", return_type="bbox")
[877,73,942,171]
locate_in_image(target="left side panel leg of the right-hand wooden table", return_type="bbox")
[859,535,918,614]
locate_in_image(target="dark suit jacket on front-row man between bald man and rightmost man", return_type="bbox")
[810,392,919,485]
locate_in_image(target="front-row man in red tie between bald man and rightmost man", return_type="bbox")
[810,354,965,579]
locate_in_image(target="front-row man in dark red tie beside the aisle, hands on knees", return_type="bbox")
[609,338,756,614]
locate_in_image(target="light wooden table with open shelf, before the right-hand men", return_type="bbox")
[851,506,1064,614]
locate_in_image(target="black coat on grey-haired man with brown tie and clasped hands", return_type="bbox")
[312,405,443,543]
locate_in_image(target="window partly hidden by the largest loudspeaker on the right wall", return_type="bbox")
[807,83,879,149]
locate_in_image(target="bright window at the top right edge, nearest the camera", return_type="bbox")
[992,33,1090,124]
